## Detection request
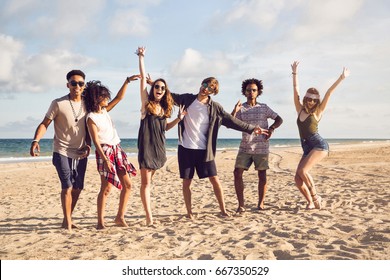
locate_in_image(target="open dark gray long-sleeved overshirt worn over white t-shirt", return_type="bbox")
[171,93,255,161]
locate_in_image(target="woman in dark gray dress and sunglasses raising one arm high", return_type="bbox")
[136,47,185,226]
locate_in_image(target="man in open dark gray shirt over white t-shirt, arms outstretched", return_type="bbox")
[172,77,268,219]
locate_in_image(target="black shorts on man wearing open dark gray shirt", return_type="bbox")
[177,145,217,179]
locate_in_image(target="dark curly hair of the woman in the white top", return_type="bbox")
[84,81,111,113]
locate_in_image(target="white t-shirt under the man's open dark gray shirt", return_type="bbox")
[179,99,210,150]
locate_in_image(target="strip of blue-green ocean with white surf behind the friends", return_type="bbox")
[0,138,389,163]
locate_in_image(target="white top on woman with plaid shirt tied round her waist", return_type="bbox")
[87,108,121,146]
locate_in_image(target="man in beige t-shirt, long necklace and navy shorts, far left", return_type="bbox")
[30,70,91,230]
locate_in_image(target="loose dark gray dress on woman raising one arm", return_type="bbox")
[138,113,167,170]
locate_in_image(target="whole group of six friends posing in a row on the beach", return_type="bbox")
[30,47,349,230]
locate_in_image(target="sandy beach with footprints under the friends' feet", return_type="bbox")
[0,141,390,260]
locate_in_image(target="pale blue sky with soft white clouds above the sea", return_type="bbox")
[0,0,390,139]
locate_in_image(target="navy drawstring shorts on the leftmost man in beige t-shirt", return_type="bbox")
[52,153,88,190]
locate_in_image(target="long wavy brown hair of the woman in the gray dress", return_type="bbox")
[145,78,174,118]
